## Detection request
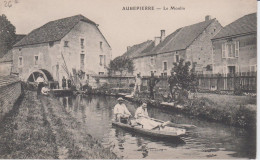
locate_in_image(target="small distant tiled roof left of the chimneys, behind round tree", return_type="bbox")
[123,40,154,58]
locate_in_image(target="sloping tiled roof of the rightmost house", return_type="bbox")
[213,13,257,39]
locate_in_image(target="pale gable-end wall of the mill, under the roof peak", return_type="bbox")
[60,22,112,74]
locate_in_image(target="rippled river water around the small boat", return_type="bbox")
[59,95,256,159]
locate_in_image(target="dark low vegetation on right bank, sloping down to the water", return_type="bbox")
[184,98,256,129]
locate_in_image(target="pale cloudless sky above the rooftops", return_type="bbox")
[0,0,257,57]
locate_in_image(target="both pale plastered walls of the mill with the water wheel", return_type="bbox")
[13,21,112,87]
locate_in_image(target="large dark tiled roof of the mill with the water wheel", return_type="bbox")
[14,15,96,47]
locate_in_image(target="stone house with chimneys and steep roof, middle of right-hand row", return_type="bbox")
[123,16,222,76]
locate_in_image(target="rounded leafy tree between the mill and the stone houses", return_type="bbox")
[109,56,134,76]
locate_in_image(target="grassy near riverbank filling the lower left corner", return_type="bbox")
[0,91,117,159]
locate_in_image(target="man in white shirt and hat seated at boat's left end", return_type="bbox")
[114,97,131,123]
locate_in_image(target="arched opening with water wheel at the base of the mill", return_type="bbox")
[27,69,54,82]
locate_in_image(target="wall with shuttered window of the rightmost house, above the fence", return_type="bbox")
[212,34,257,73]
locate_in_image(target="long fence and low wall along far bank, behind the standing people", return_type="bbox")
[90,72,257,93]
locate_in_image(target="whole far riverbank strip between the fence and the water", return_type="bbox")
[87,88,257,131]
